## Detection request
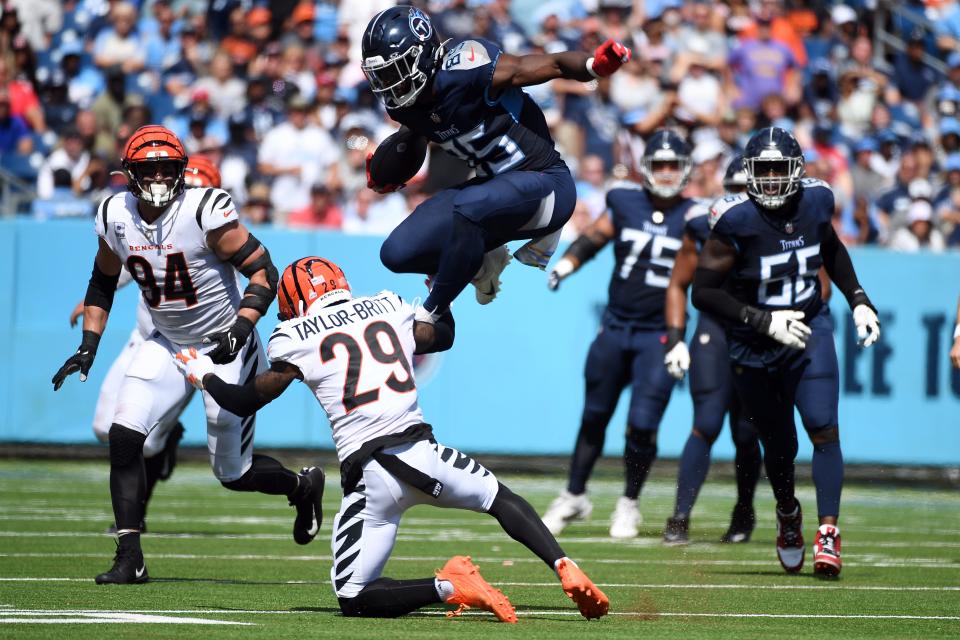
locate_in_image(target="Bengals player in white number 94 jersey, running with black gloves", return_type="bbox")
[53,125,323,584]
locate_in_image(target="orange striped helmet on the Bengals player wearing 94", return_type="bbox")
[121,124,187,207]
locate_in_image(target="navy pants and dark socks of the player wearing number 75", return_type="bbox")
[567,314,674,499]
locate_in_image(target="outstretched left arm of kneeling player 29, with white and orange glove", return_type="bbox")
[176,348,303,418]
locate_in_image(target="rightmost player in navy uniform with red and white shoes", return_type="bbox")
[692,127,880,576]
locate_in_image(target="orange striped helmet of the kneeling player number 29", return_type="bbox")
[277,256,353,320]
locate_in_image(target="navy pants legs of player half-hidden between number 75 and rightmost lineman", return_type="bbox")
[674,314,761,515]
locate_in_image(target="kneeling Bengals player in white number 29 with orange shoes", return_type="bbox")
[178,257,609,622]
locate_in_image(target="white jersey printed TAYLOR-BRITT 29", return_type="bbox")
[267,291,423,461]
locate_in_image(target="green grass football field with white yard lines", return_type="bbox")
[0,457,960,640]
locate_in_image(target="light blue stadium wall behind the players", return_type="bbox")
[0,220,960,465]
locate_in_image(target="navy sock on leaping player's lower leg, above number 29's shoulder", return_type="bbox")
[423,213,486,312]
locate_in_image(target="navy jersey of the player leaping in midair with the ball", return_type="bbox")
[387,38,562,177]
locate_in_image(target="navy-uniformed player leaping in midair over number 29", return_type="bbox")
[362,5,630,322]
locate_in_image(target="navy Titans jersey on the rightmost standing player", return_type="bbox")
[710,178,834,360]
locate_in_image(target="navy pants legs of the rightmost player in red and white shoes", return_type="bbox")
[734,307,843,518]
